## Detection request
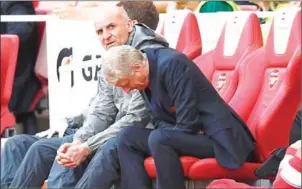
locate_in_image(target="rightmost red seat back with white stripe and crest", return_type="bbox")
[245,9,301,161]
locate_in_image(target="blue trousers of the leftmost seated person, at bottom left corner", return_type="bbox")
[1,135,72,188]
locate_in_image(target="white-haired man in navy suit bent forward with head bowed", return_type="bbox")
[102,45,255,189]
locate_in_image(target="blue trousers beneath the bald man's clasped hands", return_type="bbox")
[47,137,120,189]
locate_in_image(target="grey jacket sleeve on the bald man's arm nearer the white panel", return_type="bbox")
[74,76,118,142]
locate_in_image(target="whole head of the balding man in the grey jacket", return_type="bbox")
[91,5,133,49]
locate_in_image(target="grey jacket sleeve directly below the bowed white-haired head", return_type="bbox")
[87,90,150,151]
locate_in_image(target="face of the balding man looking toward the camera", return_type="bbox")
[95,11,133,50]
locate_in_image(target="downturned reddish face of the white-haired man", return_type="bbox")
[115,65,149,93]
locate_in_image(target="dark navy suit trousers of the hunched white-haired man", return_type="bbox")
[118,127,214,189]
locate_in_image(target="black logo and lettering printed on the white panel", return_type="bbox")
[56,47,101,87]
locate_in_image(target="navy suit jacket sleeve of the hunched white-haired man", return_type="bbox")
[163,55,201,134]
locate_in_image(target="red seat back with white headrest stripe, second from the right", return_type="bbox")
[194,12,263,103]
